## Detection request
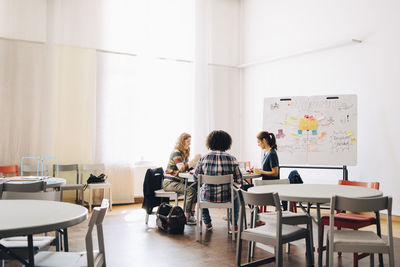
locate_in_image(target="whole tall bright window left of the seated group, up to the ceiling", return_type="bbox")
[96,0,194,166]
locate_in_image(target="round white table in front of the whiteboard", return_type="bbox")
[248,184,382,266]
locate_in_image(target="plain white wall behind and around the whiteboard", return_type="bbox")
[241,0,400,214]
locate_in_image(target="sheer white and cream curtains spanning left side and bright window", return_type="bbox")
[0,0,194,202]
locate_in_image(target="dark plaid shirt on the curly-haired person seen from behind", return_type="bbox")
[193,151,242,203]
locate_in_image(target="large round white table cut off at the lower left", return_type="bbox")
[0,199,88,266]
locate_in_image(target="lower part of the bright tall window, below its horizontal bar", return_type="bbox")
[96,53,193,166]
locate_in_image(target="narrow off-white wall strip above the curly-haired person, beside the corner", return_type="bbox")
[203,0,240,157]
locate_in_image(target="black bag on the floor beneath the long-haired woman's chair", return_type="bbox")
[156,203,186,234]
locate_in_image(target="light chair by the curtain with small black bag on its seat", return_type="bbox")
[80,164,112,212]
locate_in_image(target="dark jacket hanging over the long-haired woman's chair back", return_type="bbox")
[142,167,168,214]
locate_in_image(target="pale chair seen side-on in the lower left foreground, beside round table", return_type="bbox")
[35,199,109,267]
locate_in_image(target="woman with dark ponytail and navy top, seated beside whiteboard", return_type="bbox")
[254,131,279,180]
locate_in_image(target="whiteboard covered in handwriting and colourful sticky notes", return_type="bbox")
[263,95,357,166]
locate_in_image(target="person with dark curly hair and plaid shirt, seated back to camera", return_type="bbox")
[193,131,242,231]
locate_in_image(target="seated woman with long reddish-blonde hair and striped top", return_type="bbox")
[163,133,201,225]
